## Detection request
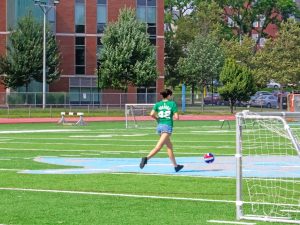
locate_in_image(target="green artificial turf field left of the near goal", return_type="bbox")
[0,121,296,225]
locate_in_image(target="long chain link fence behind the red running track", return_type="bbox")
[0,92,282,118]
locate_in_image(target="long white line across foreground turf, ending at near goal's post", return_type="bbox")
[0,188,235,203]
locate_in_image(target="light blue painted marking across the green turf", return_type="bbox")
[20,156,300,178]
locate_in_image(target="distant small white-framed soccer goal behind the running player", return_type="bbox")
[125,104,154,128]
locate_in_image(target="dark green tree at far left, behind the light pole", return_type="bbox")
[0,13,60,92]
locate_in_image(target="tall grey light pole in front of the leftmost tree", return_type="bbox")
[34,0,59,109]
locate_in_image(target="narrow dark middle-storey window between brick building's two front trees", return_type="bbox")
[75,37,85,74]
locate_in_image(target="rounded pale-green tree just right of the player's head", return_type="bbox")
[178,35,224,103]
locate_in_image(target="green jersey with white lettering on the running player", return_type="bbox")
[153,100,178,127]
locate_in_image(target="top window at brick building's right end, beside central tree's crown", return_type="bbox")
[136,0,157,45]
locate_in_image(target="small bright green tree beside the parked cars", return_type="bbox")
[218,59,255,113]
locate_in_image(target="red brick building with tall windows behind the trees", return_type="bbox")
[0,0,164,102]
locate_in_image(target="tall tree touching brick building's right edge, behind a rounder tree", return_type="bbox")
[165,1,232,87]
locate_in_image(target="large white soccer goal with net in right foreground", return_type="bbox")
[236,111,300,224]
